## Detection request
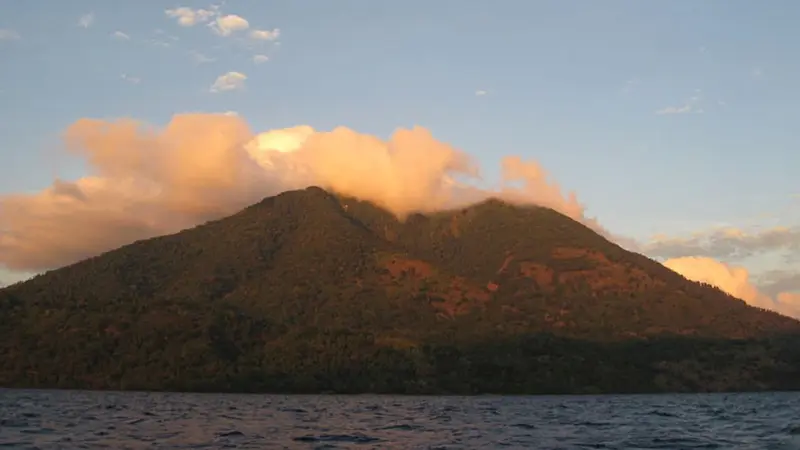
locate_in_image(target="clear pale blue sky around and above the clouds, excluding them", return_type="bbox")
[0,0,800,306]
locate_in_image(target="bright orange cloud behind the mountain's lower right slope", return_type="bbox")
[664,256,800,319]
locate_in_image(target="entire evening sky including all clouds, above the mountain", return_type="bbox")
[0,0,800,317]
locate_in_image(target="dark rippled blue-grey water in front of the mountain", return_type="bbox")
[0,390,800,450]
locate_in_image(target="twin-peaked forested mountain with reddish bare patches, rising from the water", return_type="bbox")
[0,187,800,394]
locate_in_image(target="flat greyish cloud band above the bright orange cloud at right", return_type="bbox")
[642,227,800,259]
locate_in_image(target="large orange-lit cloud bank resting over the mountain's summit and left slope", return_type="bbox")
[0,114,592,271]
